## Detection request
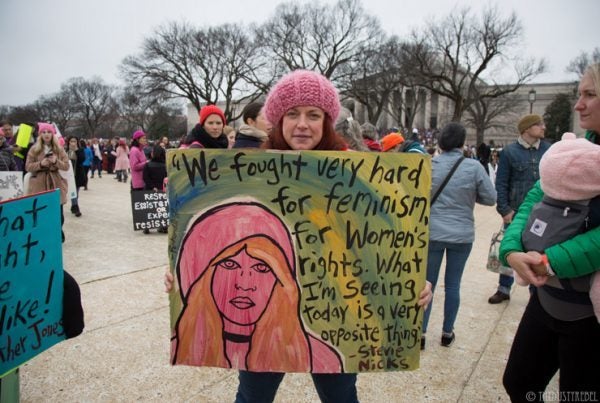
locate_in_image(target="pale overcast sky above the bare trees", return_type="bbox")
[0,0,600,105]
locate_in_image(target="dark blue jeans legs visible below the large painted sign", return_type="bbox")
[235,371,358,403]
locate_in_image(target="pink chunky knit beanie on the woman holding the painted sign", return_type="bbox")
[263,70,340,125]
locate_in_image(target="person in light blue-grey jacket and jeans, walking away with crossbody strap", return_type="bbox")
[421,122,496,350]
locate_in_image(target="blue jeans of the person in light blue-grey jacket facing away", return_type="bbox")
[423,241,473,333]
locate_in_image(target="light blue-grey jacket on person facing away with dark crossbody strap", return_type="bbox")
[429,148,496,243]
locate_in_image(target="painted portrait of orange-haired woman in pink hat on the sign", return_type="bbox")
[171,202,343,373]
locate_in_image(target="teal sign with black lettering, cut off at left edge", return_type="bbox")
[0,190,65,376]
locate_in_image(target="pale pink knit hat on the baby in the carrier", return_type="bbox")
[540,133,600,201]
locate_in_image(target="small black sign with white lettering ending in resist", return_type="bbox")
[131,190,169,231]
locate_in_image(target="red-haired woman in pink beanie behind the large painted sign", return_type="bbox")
[236,70,431,402]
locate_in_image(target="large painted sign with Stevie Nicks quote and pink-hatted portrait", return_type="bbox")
[167,150,431,373]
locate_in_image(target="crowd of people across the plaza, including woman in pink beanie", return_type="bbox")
[0,64,600,402]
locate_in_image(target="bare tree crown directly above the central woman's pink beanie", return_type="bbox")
[257,0,382,81]
